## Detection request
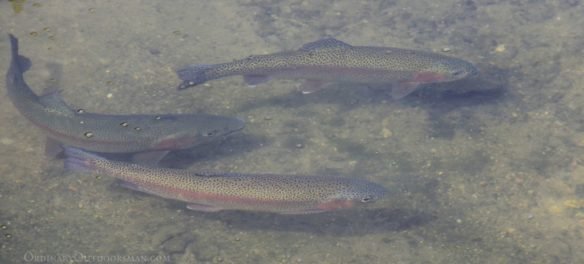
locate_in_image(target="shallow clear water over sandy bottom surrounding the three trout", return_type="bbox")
[0,0,584,263]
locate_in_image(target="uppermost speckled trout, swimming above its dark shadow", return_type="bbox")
[177,38,478,99]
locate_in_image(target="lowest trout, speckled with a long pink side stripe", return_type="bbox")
[65,147,387,214]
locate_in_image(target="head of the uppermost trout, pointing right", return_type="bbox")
[414,58,479,83]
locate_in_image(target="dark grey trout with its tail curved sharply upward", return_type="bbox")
[6,35,244,158]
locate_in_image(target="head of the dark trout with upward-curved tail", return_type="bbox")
[152,115,245,150]
